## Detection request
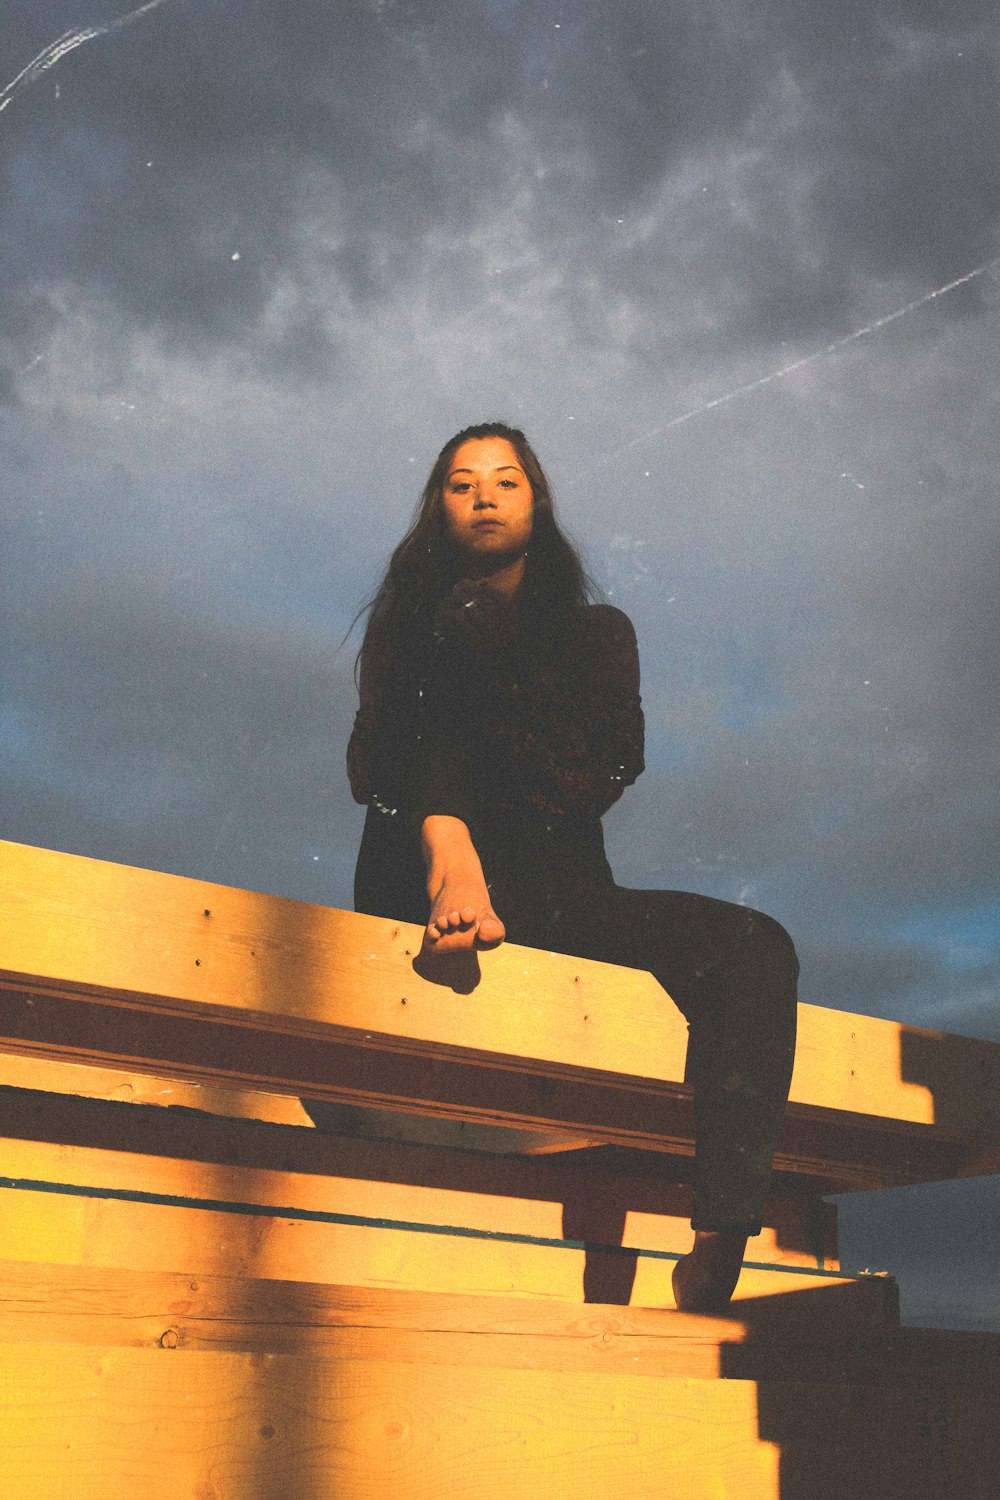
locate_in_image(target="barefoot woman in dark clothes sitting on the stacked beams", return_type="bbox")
[348,423,798,1311]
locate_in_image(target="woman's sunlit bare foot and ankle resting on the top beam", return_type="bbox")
[420,816,507,953]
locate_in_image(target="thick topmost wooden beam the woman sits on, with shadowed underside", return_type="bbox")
[0,845,1000,1187]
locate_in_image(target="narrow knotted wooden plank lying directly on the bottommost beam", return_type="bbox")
[0,1277,983,1395]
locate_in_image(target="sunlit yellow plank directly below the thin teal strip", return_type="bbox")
[0,1181,869,1317]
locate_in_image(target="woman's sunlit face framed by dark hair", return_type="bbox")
[441,438,534,573]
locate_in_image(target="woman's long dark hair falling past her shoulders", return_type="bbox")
[355,422,603,680]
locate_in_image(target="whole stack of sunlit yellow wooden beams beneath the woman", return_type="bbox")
[0,845,1000,1500]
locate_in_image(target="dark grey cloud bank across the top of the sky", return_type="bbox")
[0,0,999,393]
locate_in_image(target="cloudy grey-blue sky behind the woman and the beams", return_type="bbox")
[0,0,1000,1326]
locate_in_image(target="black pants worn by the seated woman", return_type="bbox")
[355,819,799,1235]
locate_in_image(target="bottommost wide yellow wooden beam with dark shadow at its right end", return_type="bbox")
[0,1344,1000,1500]
